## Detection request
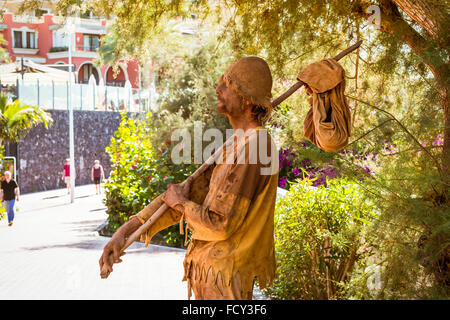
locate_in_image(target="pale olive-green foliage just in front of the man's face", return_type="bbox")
[153,37,230,136]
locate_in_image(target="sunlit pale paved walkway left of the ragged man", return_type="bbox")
[0,185,187,300]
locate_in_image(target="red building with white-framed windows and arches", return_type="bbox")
[0,0,140,89]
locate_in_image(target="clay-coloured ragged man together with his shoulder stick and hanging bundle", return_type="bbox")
[100,41,361,300]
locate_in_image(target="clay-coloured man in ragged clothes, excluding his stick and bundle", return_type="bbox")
[99,57,278,300]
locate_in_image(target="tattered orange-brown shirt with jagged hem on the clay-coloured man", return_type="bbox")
[133,127,278,298]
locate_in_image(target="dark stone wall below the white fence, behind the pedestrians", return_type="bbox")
[17,110,125,193]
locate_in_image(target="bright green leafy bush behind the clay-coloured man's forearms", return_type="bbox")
[105,114,197,246]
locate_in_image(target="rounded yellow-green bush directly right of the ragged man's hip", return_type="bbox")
[267,178,374,299]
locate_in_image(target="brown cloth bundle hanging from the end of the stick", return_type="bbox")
[297,59,351,152]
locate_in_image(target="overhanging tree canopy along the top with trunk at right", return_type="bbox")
[43,0,450,175]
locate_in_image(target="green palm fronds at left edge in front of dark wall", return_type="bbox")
[0,94,53,143]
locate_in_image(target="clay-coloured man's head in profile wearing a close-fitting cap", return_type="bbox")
[216,57,273,123]
